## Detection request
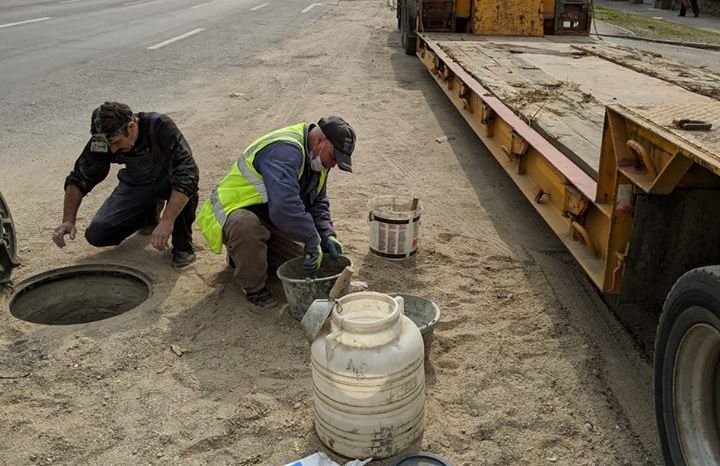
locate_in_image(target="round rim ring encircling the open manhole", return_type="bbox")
[8,263,153,325]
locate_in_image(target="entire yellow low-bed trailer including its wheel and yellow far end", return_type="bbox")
[398,0,720,465]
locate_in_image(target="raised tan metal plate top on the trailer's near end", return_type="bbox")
[614,101,720,174]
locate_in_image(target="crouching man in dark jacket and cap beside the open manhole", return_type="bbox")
[53,102,198,267]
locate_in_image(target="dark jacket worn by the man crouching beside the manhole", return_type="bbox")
[65,113,199,197]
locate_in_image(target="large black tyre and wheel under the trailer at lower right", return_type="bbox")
[654,266,720,466]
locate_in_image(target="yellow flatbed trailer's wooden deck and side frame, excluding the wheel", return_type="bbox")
[418,33,720,294]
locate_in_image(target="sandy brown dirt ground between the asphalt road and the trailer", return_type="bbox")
[0,0,660,465]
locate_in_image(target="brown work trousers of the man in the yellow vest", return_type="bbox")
[223,209,303,293]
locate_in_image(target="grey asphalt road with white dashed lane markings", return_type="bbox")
[0,0,333,166]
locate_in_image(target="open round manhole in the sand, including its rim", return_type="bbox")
[10,264,151,325]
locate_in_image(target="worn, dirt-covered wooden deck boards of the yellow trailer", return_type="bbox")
[423,33,720,179]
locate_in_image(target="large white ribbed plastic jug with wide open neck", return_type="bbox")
[311,292,425,458]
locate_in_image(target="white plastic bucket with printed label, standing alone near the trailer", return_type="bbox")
[368,196,422,260]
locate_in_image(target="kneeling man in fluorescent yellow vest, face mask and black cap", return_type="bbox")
[197,116,355,307]
